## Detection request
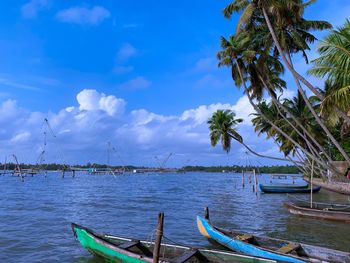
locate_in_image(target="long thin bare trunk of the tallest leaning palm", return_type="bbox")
[262,7,350,165]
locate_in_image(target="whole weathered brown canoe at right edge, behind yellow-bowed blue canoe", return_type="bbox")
[284,202,350,223]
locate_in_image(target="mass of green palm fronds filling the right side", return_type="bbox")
[208,0,350,177]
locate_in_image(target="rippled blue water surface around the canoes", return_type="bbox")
[0,173,350,263]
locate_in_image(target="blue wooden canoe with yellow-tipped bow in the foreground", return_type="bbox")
[197,213,350,263]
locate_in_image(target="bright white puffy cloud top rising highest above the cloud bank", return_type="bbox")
[77,89,126,116]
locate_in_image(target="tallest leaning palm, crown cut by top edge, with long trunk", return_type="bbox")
[224,0,350,164]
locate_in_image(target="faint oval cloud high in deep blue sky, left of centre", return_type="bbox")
[56,6,111,25]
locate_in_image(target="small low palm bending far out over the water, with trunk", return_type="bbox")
[208,110,289,161]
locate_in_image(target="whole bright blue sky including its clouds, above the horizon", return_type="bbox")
[0,0,350,166]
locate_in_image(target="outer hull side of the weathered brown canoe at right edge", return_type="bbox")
[284,202,350,223]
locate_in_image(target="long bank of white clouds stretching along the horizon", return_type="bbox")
[0,89,284,166]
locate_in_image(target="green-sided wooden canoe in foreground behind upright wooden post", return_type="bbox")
[72,223,276,263]
